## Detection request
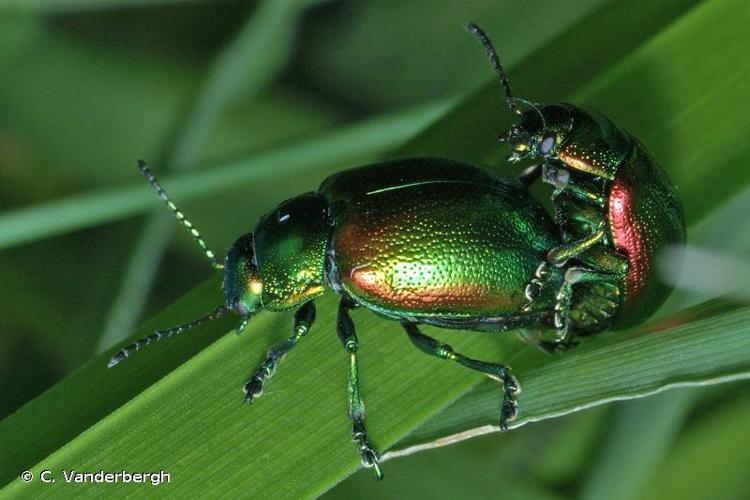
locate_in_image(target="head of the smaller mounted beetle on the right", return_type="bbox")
[506,103,573,162]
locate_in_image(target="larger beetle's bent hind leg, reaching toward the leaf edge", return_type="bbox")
[401,322,521,431]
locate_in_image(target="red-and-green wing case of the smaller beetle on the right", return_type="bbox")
[607,139,685,325]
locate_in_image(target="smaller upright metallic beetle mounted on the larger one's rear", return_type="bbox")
[467,23,685,350]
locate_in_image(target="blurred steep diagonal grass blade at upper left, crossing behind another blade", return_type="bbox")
[94,0,318,352]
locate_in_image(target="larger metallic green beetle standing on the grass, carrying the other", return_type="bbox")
[109,158,564,478]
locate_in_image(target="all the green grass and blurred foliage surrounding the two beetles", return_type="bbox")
[0,0,750,499]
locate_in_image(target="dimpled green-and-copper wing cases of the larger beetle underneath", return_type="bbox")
[326,165,559,319]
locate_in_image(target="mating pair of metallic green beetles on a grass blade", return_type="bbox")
[109,24,685,478]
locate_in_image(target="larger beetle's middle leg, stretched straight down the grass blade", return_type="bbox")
[336,297,383,479]
